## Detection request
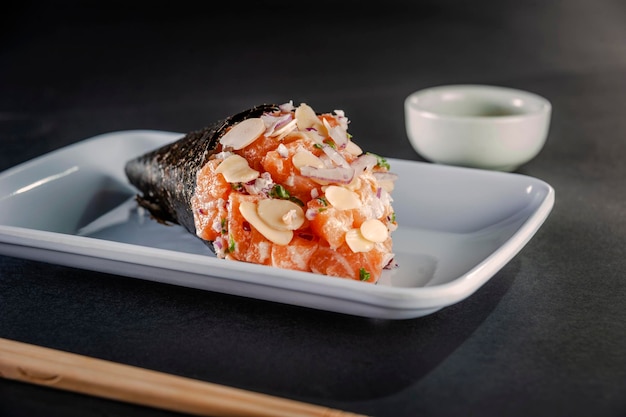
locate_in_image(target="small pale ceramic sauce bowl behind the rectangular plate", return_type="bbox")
[404,84,552,171]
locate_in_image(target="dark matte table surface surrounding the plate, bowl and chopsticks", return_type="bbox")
[0,0,626,417]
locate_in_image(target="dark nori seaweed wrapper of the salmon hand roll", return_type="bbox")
[125,104,278,235]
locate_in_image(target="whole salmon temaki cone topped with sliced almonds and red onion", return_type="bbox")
[126,102,397,283]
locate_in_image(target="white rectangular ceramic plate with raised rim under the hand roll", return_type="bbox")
[0,130,554,319]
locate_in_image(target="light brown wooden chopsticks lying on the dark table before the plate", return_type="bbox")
[0,338,365,417]
